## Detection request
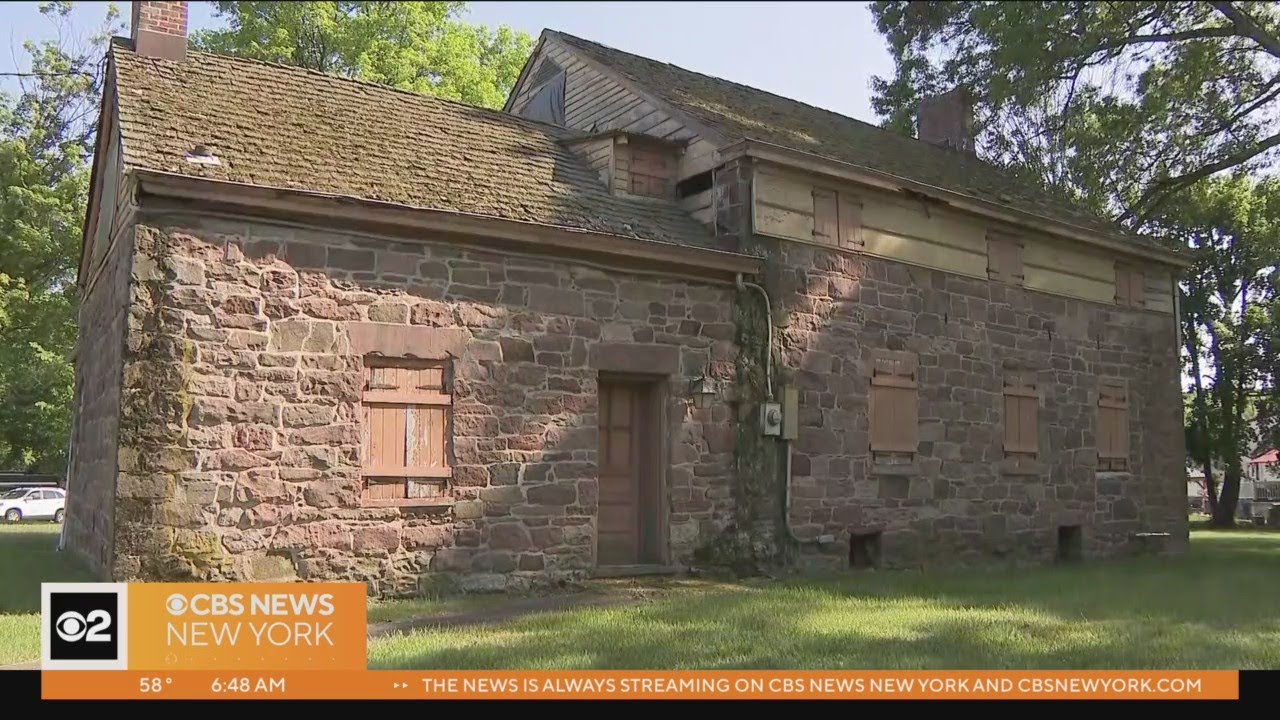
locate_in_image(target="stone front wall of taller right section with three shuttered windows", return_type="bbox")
[777,242,1187,566]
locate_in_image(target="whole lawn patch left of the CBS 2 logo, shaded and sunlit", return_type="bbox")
[0,521,92,665]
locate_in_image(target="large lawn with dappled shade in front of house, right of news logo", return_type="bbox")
[370,533,1280,669]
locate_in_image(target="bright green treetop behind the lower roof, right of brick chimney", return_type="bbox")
[192,1,534,108]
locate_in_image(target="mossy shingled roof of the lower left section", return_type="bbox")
[111,38,716,247]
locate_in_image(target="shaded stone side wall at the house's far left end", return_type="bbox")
[63,221,133,579]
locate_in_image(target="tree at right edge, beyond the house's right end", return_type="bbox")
[1148,173,1280,527]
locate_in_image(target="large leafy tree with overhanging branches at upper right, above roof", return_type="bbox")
[872,0,1280,227]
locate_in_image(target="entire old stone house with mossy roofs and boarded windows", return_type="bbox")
[64,3,1187,594]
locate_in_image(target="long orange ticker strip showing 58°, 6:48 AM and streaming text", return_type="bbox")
[41,670,1239,700]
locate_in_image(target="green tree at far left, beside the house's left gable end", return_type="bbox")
[0,3,120,474]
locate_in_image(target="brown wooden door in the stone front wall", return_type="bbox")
[595,379,662,565]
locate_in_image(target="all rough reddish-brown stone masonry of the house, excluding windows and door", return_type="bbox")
[68,207,1187,594]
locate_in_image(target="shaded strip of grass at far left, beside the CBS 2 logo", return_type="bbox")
[0,521,92,615]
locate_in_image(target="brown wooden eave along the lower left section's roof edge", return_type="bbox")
[129,168,763,282]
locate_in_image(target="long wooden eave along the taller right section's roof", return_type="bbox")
[717,138,1190,268]
